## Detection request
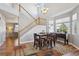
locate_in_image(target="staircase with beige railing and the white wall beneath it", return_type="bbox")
[19,5,46,43]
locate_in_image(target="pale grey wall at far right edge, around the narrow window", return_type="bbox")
[71,6,79,48]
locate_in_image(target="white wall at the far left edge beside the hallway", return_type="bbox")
[0,14,6,45]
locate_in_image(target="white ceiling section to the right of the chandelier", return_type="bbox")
[45,3,78,17]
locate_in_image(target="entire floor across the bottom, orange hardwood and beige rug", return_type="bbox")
[0,39,79,56]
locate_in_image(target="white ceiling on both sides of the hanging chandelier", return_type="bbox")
[22,3,78,17]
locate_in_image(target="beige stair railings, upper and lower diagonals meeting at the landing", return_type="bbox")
[19,5,46,36]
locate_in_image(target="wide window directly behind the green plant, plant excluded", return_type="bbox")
[56,17,70,33]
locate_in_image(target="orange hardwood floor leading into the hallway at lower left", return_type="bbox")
[0,37,14,56]
